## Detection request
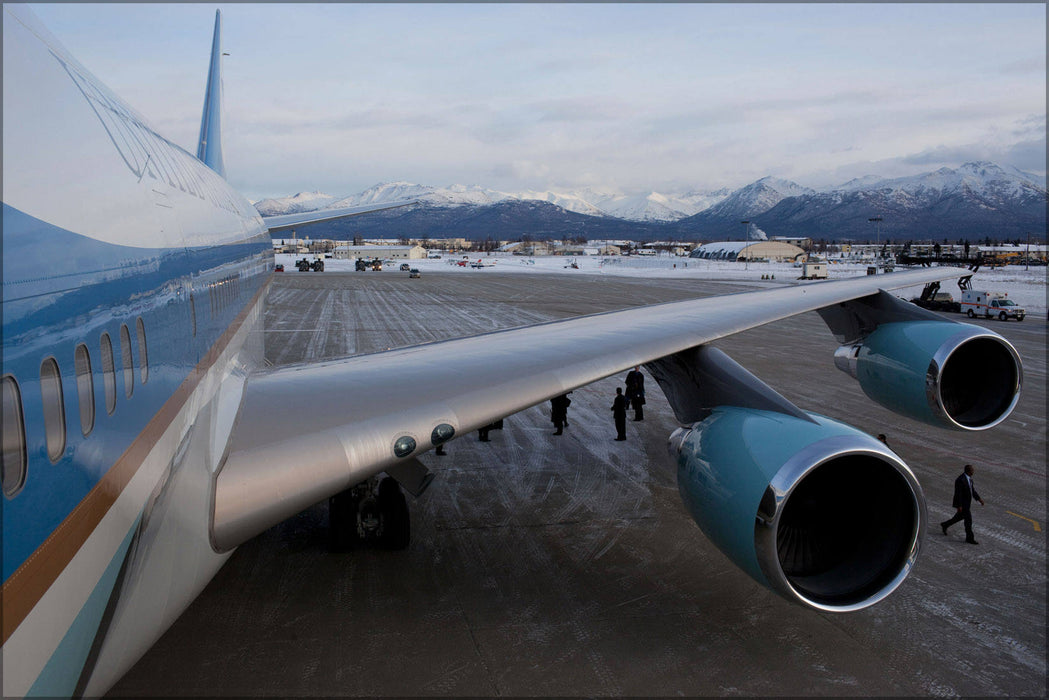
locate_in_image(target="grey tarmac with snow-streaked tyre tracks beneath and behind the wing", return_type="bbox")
[111,271,1047,697]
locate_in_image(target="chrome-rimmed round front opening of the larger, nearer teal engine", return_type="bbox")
[755,444,925,612]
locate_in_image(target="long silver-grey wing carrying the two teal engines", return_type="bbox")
[213,268,981,550]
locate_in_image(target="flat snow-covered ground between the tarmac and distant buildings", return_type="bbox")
[276,253,1049,318]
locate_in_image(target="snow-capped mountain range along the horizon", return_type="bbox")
[255,163,1049,240]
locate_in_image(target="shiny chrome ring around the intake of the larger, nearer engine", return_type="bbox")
[754,434,928,613]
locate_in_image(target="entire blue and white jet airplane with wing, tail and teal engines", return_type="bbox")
[2,4,1022,696]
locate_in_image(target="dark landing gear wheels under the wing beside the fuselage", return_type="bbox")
[328,476,411,552]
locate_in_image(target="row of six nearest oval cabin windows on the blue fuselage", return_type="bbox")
[0,317,149,499]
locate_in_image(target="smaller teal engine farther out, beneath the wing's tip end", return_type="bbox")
[834,321,1023,430]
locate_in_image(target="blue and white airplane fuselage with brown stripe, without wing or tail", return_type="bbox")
[3,6,273,695]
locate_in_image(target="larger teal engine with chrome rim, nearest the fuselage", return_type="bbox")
[670,406,925,612]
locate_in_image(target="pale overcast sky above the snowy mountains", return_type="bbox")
[28,3,1046,199]
